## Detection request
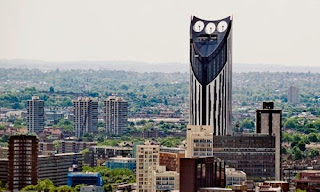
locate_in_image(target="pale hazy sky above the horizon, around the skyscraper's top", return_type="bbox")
[0,0,320,66]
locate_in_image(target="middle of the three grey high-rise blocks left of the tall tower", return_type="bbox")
[73,97,98,138]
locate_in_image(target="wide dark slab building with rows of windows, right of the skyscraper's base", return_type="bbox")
[213,134,280,181]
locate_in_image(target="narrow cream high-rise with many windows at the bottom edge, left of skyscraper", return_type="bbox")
[136,142,160,192]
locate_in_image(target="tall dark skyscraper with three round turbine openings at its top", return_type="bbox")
[189,17,232,135]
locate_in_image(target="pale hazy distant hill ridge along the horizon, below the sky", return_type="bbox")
[0,59,320,73]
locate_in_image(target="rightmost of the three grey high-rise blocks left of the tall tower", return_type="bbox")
[104,96,128,136]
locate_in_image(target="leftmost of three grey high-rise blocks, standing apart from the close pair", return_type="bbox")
[27,96,44,133]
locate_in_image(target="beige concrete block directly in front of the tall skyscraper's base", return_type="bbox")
[186,125,213,158]
